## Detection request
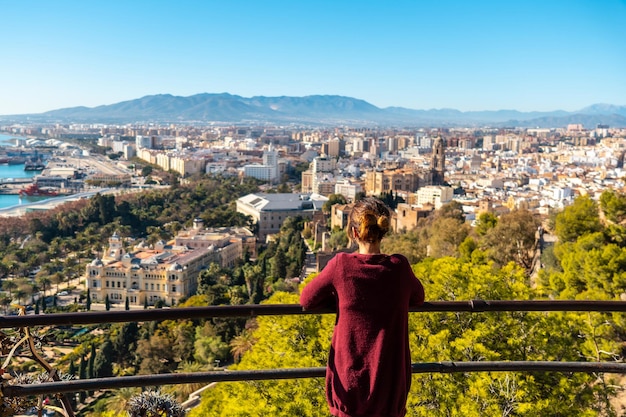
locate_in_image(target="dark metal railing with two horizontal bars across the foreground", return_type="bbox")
[0,300,626,397]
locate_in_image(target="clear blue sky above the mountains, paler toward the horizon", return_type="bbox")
[0,0,626,115]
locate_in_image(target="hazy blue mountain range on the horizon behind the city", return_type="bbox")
[0,93,626,128]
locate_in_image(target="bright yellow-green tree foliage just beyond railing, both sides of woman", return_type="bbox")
[190,257,616,417]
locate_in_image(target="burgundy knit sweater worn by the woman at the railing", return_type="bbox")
[300,253,424,417]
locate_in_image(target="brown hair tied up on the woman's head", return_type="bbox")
[347,197,391,242]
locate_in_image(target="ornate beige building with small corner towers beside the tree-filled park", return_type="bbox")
[86,222,251,305]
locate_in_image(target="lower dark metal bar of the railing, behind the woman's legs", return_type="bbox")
[2,361,626,397]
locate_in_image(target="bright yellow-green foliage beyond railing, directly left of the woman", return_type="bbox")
[189,293,334,417]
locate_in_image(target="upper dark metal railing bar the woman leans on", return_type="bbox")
[0,300,626,329]
